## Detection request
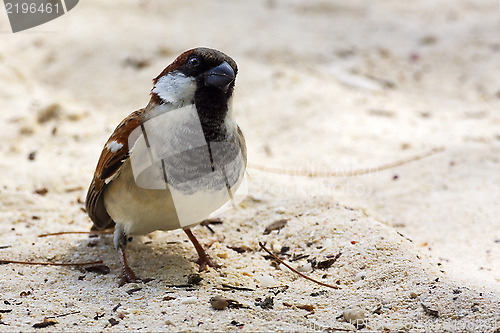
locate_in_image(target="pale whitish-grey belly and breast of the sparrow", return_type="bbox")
[104,107,245,235]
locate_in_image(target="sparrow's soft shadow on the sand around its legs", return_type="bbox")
[67,231,198,285]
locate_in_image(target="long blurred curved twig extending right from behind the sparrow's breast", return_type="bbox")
[248,147,445,178]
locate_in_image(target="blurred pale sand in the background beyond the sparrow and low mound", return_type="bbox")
[0,0,500,291]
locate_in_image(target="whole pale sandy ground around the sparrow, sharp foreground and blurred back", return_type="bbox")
[0,0,500,332]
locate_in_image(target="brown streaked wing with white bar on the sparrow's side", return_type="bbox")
[85,109,145,229]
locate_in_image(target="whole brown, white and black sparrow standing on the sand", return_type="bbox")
[85,47,247,285]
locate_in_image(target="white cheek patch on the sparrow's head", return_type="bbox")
[153,71,196,107]
